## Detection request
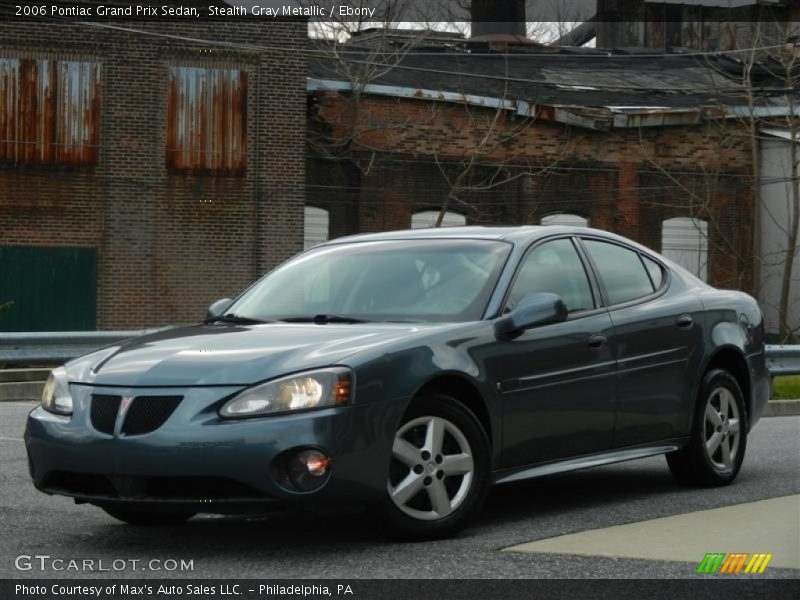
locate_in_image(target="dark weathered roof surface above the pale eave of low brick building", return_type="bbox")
[309,41,792,108]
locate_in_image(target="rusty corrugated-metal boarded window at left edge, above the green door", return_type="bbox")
[0,58,100,165]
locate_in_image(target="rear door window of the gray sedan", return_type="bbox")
[583,240,654,305]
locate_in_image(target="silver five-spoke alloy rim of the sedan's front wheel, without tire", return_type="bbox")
[388,416,475,521]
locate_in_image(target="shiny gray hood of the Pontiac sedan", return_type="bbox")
[66,323,446,387]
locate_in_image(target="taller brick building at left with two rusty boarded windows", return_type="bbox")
[0,9,308,331]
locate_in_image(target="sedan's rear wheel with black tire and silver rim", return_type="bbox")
[667,369,747,487]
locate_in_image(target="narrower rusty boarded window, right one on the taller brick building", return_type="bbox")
[167,67,247,172]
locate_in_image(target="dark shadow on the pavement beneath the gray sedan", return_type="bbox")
[75,465,678,558]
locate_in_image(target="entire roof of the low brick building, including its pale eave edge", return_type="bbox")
[308,44,796,129]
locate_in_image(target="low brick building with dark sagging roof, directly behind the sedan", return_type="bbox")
[307,38,792,290]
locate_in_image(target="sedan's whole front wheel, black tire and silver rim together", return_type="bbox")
[380,394,491,540]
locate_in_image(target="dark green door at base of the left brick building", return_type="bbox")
[0,246,97,331]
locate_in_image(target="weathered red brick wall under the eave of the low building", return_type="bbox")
[308,92,753,290]
